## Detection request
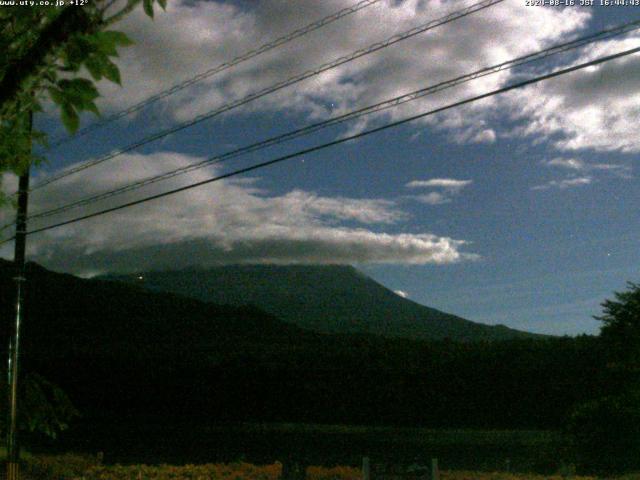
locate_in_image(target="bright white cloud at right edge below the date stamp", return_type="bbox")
[503,33,640,153]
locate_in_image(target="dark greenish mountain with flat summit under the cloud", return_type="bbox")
[109,265,533,341]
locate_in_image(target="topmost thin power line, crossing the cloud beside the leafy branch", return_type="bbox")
[50,0,381,149]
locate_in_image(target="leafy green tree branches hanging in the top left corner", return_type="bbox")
[0,0,166,200]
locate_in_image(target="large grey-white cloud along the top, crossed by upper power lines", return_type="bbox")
[87,0,590,143]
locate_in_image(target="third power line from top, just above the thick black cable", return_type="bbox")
[18,16,640,223]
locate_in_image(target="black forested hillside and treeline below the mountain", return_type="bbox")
[0,263,615,429]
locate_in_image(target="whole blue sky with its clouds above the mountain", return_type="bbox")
[3,0,640,335]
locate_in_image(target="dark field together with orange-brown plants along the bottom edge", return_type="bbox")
[8,423,640,480]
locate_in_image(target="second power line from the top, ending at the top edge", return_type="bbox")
[31,0,504,191]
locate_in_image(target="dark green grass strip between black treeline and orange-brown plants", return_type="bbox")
[51,423,570,473]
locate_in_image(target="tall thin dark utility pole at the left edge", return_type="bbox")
[7,112,33,480]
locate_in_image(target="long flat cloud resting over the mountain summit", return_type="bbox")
[0,152,475,274]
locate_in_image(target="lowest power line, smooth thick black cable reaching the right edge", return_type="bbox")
[3,43,640,243]
